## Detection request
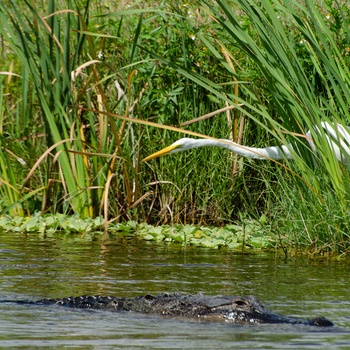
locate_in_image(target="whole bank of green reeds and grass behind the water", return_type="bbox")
[0,0,350,254]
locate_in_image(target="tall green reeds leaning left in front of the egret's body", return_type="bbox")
[175,0,350,249]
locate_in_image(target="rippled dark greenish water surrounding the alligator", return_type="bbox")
[0,233,350,349]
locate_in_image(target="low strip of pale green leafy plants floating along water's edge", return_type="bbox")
[0,214,277,252]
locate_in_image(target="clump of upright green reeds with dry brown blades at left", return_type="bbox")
[0,0,150,219]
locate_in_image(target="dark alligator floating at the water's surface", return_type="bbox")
[6,293,334,327]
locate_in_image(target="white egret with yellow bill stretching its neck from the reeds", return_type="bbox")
[143,122,350,163]
